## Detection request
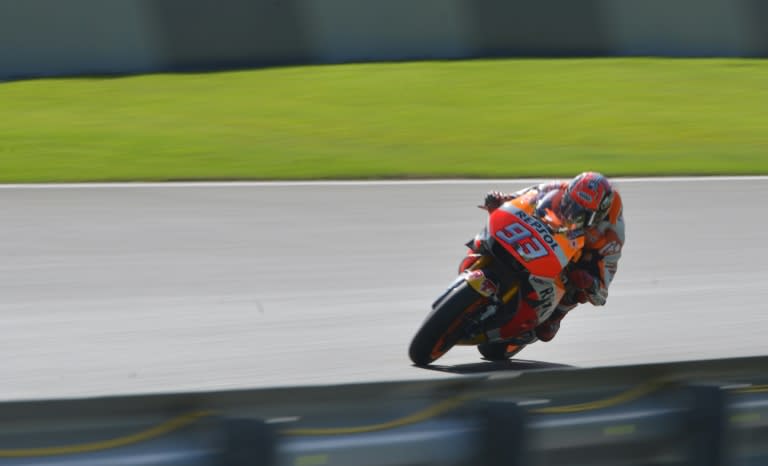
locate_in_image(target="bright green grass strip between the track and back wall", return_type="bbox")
[0,59,768,182]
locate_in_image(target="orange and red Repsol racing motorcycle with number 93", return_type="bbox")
[409,194,584,366]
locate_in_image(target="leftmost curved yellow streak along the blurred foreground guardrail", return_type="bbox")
[0,411,212,458]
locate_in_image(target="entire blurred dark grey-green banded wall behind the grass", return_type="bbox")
[0,0,768,79]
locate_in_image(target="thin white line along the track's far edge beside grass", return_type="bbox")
[0,176,768,189]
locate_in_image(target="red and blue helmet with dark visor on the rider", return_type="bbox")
[559,172,613,228]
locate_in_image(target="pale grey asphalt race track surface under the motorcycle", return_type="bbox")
[0,177,768,399]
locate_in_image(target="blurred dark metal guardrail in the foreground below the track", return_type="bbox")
[0,357,768,466]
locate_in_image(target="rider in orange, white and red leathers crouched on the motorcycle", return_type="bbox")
[459,172,624,342]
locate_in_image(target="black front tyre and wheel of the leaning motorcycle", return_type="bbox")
[408,282,488,366]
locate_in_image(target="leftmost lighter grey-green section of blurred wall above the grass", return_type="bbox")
[0,0,163,79]
